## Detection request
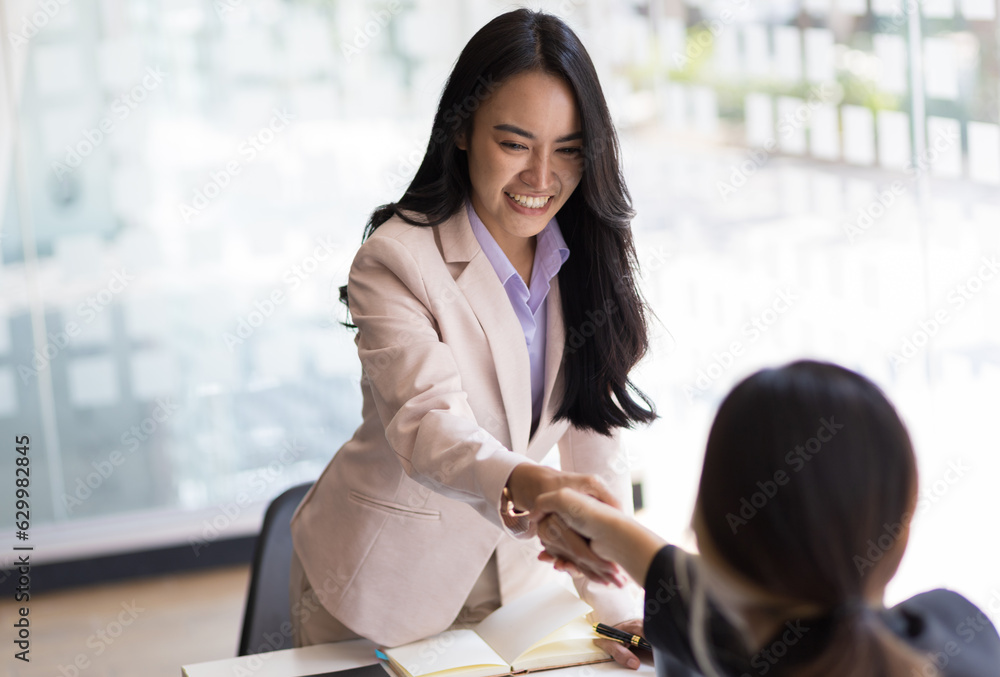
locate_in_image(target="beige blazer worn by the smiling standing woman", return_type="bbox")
[292,209,637,646]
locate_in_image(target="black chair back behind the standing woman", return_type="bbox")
[238,482,313,656]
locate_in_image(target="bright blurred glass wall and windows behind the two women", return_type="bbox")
[0,0,1000,674]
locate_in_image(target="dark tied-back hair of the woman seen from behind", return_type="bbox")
[695,361,929,677]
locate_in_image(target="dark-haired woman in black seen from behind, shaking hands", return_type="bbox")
[532,361,1000,677]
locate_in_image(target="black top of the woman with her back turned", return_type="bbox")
[644,545,1000,677]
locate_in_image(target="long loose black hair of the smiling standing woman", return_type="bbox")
[340,9,657,435]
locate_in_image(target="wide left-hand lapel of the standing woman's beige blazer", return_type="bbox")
[438,208,532,454]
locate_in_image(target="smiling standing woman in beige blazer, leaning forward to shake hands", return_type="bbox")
[291,9,656,667]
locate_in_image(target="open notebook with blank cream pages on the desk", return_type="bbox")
[384,584,611,677]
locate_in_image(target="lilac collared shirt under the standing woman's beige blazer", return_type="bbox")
[465,201,569,430]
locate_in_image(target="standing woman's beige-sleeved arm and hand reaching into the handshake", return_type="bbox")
[348,237,617,548]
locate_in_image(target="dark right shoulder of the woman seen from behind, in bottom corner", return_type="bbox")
[892,590,1000,677]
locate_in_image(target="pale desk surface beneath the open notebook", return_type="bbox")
[181,639,656,677]
